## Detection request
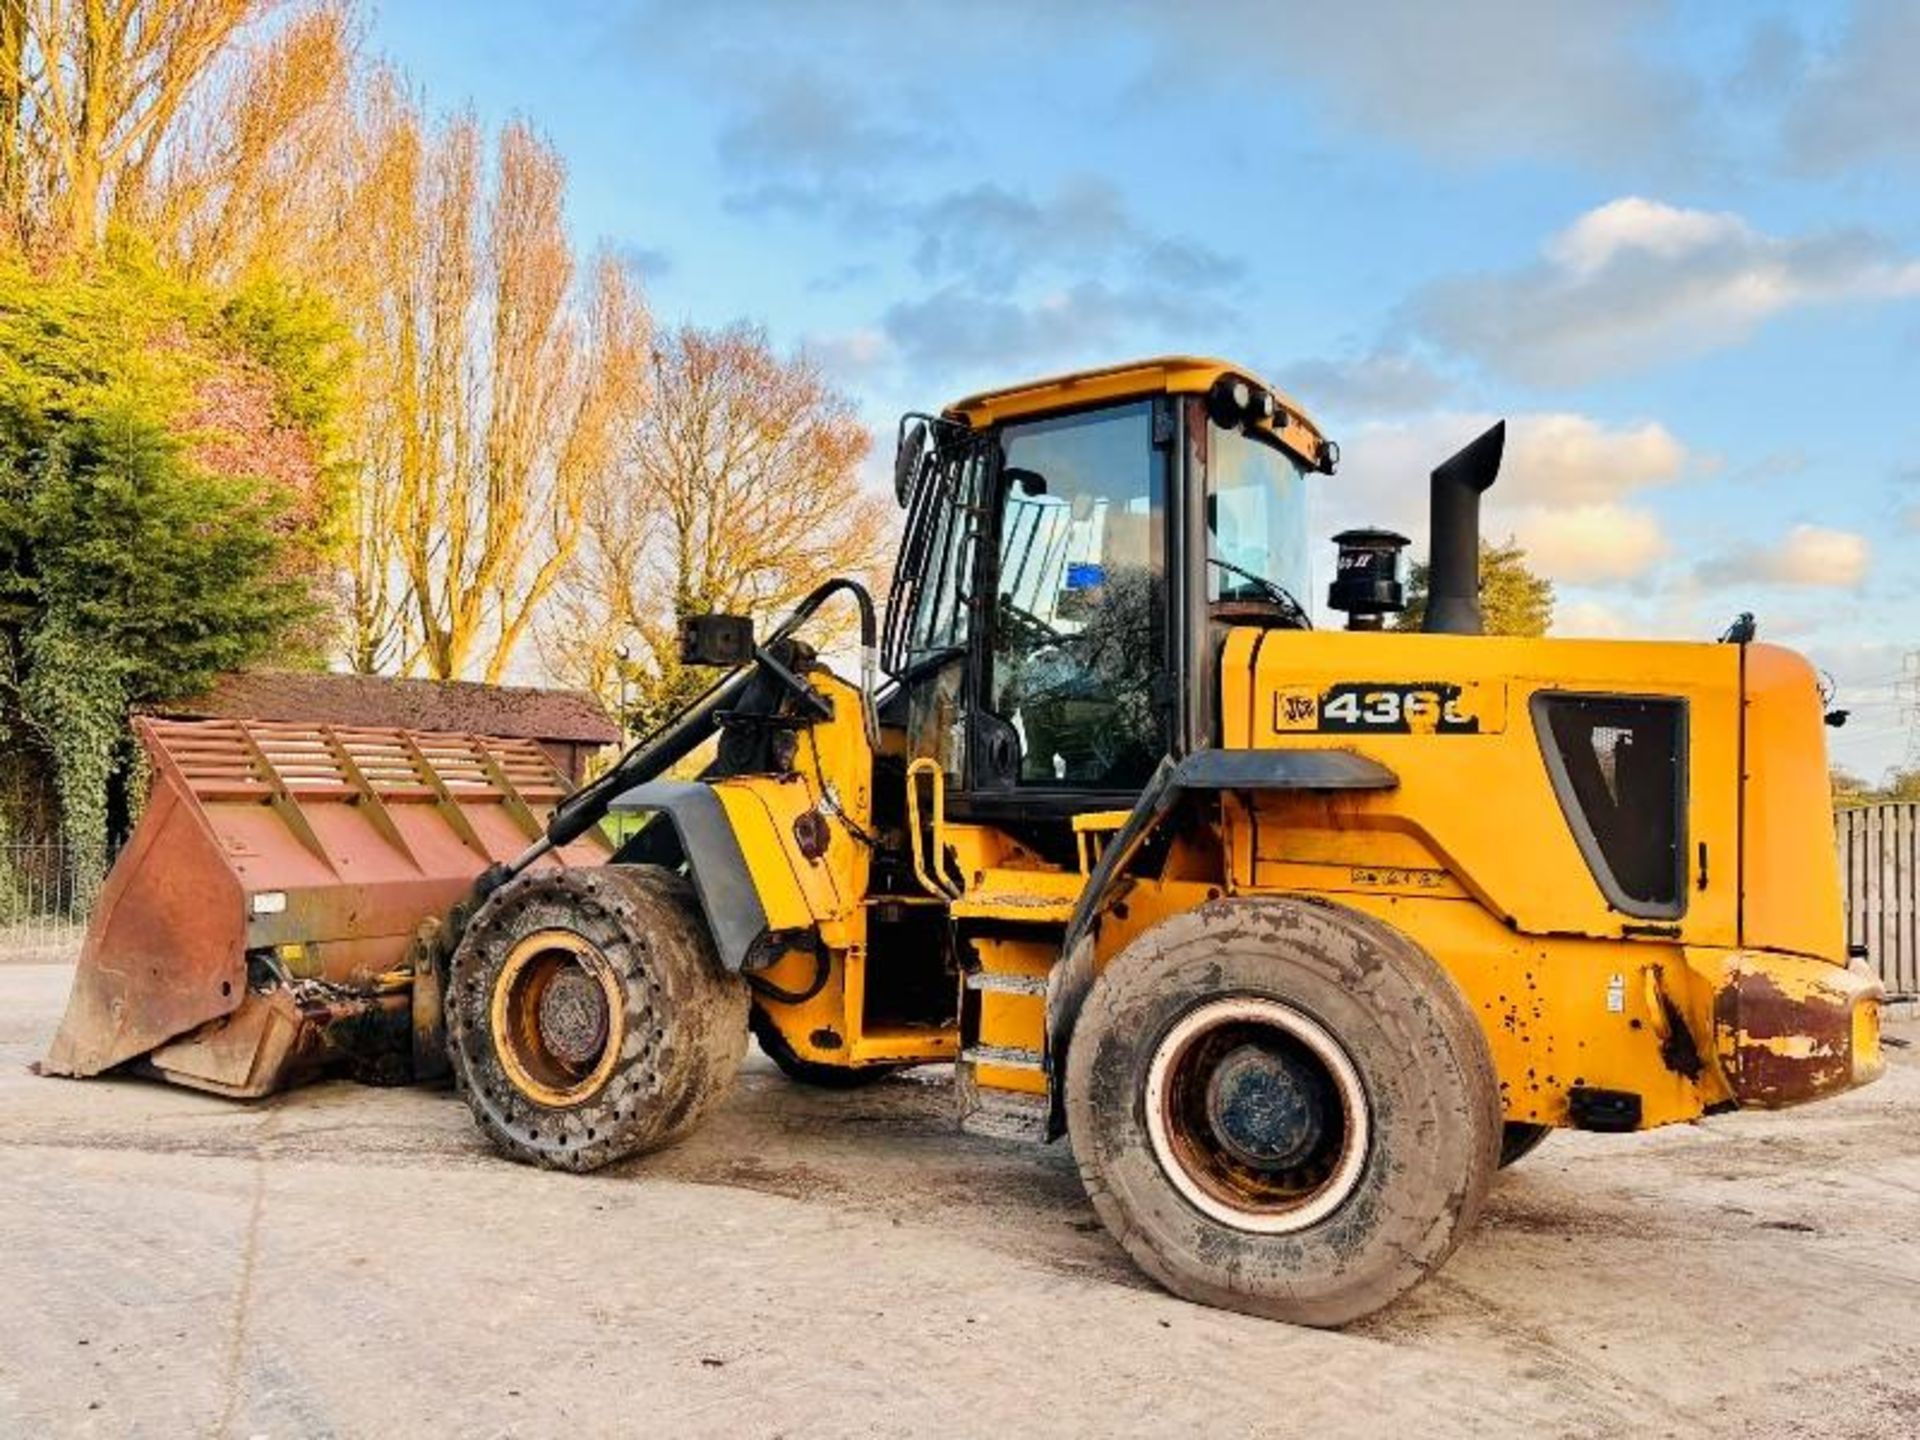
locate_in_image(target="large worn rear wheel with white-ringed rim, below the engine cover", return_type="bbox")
[1066,899,1501,1325]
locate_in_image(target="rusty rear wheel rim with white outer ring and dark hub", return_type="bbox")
[1144,995,1371,1235]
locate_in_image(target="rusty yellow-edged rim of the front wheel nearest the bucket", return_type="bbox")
[492,929,626,1110]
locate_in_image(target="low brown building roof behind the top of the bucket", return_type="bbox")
[150,670,620,745]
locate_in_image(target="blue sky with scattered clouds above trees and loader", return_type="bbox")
[369,0,1920,774]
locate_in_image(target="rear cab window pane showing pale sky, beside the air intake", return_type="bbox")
[1206,424,1313,605]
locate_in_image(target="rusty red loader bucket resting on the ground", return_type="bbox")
[40,718,607,1096]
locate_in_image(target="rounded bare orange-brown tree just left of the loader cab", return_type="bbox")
[543,324,891,730]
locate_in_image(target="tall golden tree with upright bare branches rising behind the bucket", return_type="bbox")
[349,107,649,682]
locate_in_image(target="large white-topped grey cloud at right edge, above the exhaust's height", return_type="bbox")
[1407,196,1920,384]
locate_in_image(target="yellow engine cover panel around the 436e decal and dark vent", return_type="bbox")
[1221,630,1741,945]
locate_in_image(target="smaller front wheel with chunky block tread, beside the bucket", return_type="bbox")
[447,866,747,1171]
